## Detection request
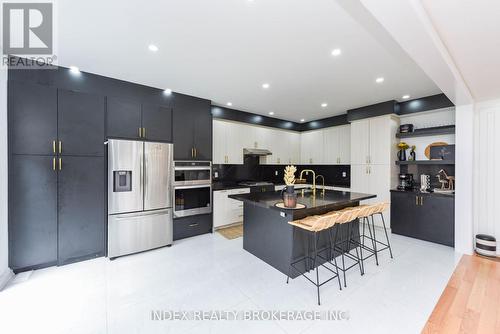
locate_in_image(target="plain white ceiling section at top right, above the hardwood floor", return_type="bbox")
[423,0,500,101]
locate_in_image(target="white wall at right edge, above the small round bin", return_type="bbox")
[474,100,500,256]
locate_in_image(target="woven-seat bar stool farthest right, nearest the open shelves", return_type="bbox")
[361,203,393,266]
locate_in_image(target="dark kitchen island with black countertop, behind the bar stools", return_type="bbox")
[229,190,376,277]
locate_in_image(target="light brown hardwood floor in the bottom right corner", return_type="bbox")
[422,255,500,334]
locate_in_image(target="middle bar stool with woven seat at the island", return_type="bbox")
[333,207,364,287]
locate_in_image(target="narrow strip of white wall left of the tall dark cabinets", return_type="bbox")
[0,67,11,290]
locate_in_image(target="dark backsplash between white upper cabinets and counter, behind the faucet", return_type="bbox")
[213,156,351,187]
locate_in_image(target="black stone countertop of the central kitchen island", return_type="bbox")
[228,190,377,213]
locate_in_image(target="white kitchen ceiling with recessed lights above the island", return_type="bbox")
[57,0,440,121]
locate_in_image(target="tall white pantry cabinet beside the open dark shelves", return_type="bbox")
[351,115,399,226]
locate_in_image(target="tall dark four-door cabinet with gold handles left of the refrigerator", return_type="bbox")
[8,81,105,272]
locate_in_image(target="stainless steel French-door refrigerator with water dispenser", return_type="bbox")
[108,139,174,258]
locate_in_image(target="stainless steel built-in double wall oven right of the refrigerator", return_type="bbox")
[174,161,212,217]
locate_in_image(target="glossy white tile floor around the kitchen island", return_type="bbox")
[0,234,459,334]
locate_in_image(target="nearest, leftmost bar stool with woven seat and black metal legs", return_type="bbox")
[286,214,342,305]
